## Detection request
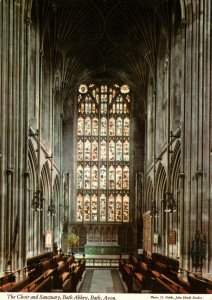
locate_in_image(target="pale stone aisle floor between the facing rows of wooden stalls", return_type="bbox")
[79,269,125,293]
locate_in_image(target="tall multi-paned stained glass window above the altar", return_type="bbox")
[76,84,130,222]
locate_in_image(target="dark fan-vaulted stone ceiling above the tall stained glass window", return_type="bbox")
[36,0,170,100]
